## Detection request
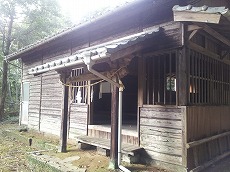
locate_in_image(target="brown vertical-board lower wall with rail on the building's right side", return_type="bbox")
[187,106,230,169]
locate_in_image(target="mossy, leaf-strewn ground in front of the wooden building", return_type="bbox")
[0,118,170,172]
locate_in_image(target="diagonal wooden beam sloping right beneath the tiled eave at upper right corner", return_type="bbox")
[197,23,230,47]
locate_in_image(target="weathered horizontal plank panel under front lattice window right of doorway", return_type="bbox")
[140,106,183,165]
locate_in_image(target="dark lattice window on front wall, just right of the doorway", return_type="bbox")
[145,51,177,105]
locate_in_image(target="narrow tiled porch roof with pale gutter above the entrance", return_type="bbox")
[29,28,159,74]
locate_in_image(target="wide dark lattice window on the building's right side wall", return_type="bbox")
[189,50,230,105]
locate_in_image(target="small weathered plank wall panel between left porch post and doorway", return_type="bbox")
[69,103,88,139]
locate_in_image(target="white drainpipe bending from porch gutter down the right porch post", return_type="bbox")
[84,55,131,172]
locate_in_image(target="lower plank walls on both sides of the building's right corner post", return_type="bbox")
[137,105,230,171]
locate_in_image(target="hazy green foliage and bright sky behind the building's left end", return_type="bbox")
[0,0,71,117]
